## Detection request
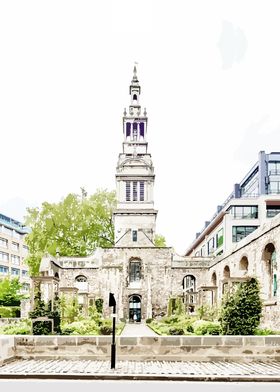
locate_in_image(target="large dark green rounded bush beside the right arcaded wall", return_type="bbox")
[220,278,262,335]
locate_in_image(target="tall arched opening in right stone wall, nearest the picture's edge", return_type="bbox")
[262,243,277,297]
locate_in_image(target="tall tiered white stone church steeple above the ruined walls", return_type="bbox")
[114,66,157,247]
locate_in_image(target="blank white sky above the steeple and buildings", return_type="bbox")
[0,0,280,254]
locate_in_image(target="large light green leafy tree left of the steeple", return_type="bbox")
[25,188,116,275]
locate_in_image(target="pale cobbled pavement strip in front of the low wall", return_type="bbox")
[0,360,280,382]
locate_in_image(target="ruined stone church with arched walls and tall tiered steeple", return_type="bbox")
[33,67,280,328]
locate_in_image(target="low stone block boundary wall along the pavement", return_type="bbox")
[4,335,280,361]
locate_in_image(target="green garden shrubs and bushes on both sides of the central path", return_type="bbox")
[0,278,280,335]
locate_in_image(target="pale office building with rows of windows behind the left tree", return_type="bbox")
[0,214,30,292]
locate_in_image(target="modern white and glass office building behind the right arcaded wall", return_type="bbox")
[186,151,280,257]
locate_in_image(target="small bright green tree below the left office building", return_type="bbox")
[0,278,23,306]
